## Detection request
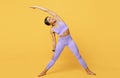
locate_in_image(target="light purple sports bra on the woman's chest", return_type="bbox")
[52,22,68,35]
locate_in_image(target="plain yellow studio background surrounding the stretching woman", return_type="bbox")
[0,0,120,78]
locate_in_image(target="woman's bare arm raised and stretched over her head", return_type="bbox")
[30,6,63,21]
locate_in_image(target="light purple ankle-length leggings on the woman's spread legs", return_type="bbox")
[46,35,87,69]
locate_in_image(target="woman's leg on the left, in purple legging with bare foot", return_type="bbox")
[38,41,65,77]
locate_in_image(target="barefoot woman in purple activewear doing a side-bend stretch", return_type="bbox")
[30,6,96,77]
